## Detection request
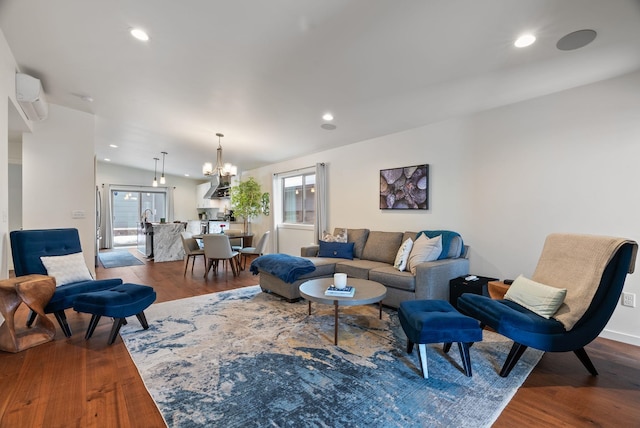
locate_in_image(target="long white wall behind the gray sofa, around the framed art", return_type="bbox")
[248,73,640,345]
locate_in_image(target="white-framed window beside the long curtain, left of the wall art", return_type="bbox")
[282,173,316,225]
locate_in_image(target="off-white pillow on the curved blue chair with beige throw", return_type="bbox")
[504,275,567,319]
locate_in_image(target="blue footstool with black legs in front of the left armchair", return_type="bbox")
[73,284,156,345]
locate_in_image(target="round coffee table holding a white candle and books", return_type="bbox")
[300,278,387,345]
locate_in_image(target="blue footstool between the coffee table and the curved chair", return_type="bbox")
[398,300,482,379]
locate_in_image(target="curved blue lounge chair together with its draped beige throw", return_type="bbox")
[457,234,638,377]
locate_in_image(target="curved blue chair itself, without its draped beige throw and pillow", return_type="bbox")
[457,235,638,377]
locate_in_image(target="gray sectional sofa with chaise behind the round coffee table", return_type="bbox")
[260,228,469,308]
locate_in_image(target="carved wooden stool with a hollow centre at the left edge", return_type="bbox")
[0,275,56,352]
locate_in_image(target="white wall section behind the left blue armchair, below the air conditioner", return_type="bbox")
[22,104,96,270]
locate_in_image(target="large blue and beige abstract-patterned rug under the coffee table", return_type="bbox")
[121,286,542,428]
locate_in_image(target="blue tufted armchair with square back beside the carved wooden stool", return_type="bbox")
[9,229,122,337]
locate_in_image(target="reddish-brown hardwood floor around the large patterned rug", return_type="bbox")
[0,250,640,428]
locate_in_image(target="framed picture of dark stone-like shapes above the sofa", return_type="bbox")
[380,164,429,210]
